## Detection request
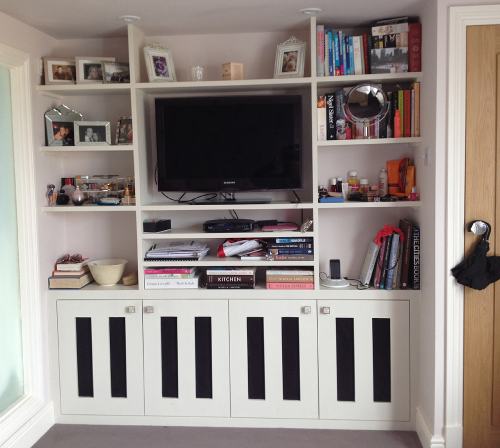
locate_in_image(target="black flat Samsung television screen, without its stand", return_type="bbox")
[155,95,302,192]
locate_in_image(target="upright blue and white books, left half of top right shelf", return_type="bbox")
[316,25,370,76]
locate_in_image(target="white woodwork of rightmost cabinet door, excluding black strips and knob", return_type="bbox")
[318,300,410,421]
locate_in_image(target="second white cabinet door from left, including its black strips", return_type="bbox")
[143,300,229,417]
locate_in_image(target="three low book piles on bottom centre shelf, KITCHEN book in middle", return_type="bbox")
[144,267,314,289]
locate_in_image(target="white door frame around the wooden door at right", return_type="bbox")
[445,5,500,448]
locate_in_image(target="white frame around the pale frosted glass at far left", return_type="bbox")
[0,44,49,446]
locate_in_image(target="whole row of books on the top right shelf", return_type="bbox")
[316,17,422,76]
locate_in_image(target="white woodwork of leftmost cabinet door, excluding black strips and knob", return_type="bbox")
[57,300,144,415]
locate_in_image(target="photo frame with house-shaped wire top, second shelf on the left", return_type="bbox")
[44,104,83,146]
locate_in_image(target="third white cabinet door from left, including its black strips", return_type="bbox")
[229,299,318,418]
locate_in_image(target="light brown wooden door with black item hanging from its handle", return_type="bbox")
[463,26,500,448]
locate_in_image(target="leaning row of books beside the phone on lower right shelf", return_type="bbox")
[359,219,420,289]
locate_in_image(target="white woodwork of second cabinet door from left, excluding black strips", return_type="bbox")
[143,300,230,417]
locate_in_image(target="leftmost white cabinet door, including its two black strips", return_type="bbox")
[57,300,144,415]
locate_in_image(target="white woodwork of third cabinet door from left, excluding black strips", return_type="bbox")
[229,300,318,418]
